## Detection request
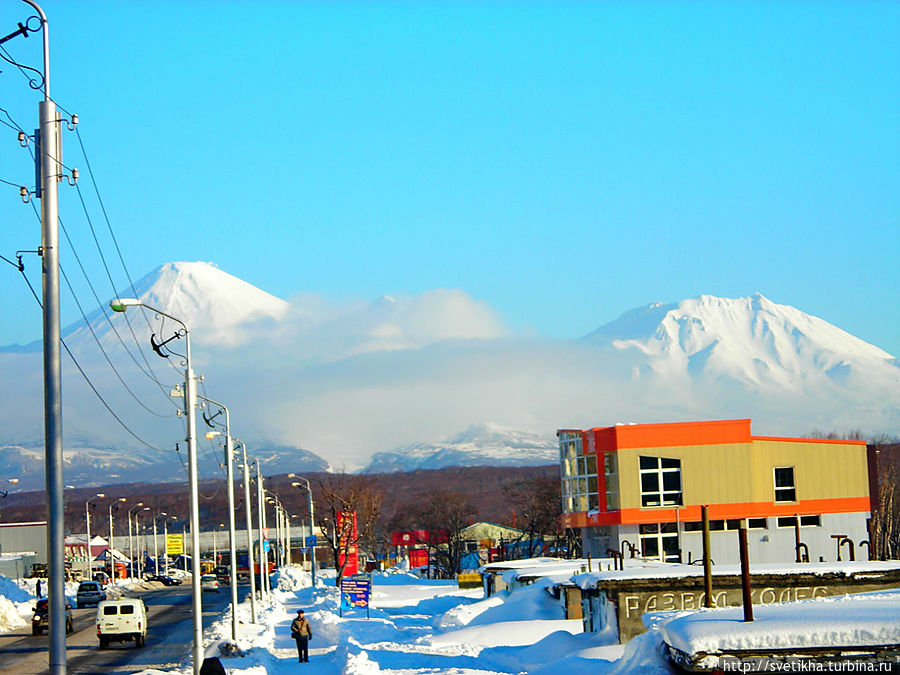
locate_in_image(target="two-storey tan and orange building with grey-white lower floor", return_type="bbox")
[557,419,870,564]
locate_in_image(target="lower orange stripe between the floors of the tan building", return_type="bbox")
[562,497,871,527]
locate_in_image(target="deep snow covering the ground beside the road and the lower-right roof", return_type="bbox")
[0,567,900,675]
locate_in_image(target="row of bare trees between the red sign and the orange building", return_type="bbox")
[316,472,563,584]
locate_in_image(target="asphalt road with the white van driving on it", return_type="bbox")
[0,583,250,675]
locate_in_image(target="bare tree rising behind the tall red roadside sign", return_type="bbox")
[316,472,383,586]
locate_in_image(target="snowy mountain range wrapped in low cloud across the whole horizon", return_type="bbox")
[0,263,900,482]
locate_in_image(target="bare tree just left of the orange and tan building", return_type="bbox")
[506,476,562,558]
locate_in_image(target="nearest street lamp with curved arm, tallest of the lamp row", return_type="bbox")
[109,298,203,675]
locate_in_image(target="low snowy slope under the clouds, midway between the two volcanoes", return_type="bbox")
[366,424,559,473]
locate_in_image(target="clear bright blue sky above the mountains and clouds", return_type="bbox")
[0,0,900,355]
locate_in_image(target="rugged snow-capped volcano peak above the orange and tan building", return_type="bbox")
[583,293,900,390]
